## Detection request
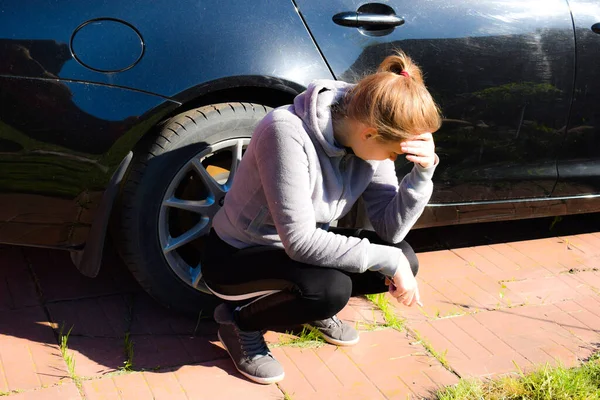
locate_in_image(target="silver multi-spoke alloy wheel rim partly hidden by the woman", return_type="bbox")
[158,138,250,293]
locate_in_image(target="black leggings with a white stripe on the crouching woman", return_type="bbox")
[202,228,419,331]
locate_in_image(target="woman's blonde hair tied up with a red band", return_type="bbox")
[334,51,442,141]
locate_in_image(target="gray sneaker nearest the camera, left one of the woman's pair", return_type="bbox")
[214,304,285,384]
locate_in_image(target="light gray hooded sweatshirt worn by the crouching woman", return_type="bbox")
[213,80,435,276]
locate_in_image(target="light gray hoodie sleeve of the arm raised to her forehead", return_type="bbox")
[363,156,438,243]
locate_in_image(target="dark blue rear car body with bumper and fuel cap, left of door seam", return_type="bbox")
[0,0,332,249]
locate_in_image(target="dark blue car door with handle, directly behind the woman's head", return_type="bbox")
[296,0,575,204]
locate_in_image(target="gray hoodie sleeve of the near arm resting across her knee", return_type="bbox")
[255,122,402,276]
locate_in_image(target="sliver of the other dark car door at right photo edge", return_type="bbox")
[552,0,600,198]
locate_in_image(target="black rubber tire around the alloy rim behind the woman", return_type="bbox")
[116,103,270,316]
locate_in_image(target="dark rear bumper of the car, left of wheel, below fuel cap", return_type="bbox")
[0,77,180,248]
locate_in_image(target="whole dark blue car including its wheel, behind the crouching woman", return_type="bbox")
[0,0,600,315]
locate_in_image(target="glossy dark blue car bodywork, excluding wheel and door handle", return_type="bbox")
[0,0,600,249]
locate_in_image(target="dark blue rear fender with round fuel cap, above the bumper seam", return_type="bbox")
[0,0,331,97]
